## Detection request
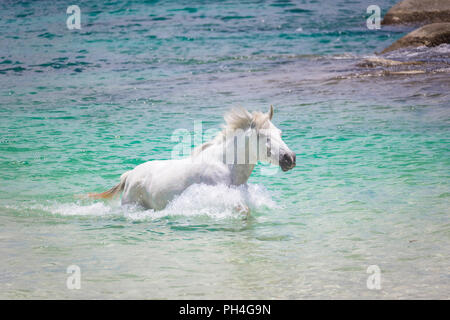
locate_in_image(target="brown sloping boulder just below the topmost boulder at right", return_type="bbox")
[381,22,450,53]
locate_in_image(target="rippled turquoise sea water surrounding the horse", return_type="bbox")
[0,0,450,299]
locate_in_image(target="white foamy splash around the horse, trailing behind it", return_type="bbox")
[10,184,276,220]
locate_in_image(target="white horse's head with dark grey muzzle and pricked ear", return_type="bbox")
[257,106,296,171]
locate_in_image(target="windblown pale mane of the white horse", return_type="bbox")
[192,107,269,156]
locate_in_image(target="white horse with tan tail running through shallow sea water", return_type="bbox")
[88,106,295,210]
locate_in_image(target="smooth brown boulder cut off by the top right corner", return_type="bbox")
[382,0,450,24]
